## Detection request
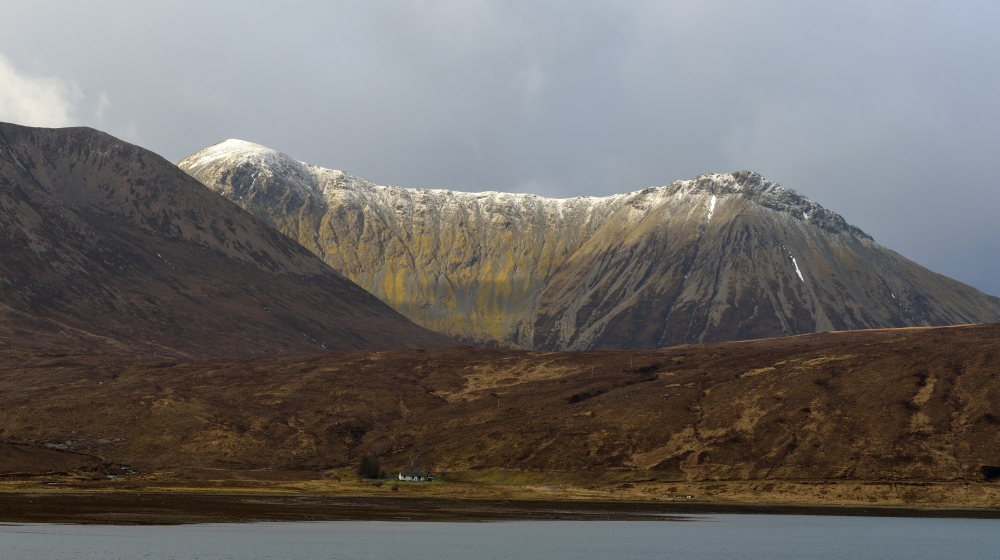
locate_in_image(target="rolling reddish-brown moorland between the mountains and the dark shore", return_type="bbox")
[0,325,1000,508]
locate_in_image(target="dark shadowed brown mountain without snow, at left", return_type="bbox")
[0,124,454,356]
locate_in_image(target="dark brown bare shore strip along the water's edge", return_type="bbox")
[0,491,1000,525]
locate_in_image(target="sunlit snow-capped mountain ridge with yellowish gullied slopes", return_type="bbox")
[179,140,1000,350]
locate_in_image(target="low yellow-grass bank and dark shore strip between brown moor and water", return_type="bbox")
[0,470,1000,524]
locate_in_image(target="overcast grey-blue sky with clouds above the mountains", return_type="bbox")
[0,0,1000,295]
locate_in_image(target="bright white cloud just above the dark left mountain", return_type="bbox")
[0,53,80,127]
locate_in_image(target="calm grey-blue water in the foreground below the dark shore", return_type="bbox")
[0,515,1000,560]
